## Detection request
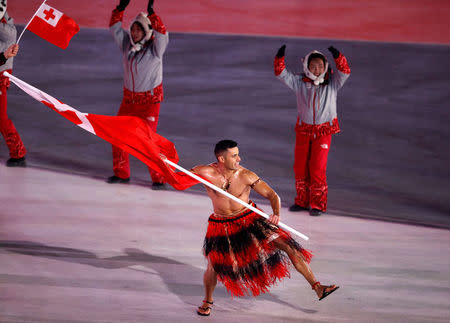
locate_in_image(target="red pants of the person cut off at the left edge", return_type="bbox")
[0,70,27,158]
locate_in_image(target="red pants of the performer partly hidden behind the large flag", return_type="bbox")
[112,97,165,183]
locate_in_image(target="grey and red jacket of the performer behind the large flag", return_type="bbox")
[109,9,169,103]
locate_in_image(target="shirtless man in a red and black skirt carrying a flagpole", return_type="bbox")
[192,140,339,316]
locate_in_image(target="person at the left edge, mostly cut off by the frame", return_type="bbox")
[0,6,27,167]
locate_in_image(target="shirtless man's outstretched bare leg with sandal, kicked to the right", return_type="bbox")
[273,238,336,298]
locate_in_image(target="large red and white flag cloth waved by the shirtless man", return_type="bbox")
[3,72,199,190]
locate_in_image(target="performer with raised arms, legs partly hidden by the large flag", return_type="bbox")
[107,0,169,189]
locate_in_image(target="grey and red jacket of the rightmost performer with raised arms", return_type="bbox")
[274,54,350,137]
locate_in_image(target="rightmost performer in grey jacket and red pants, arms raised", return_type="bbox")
[274,45,350,216]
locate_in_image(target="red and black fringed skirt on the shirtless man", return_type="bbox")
[203,202,312,297]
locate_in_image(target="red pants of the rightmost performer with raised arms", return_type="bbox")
[294,131,331,212]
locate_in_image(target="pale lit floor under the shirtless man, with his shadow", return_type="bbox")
[0,165,450,323]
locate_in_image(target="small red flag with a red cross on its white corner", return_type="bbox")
[27,3,80,49]
